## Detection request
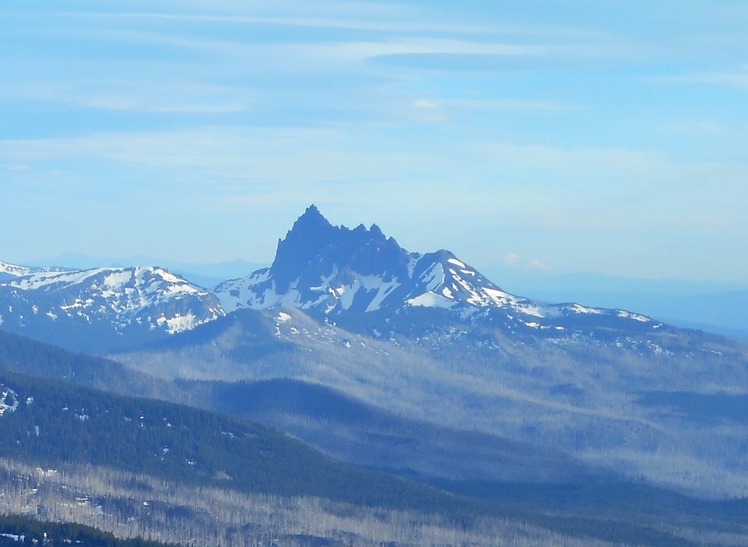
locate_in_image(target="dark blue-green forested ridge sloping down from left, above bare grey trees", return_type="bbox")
[0,371,468,510]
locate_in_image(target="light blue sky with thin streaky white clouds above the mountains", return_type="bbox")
[0,0,748,282]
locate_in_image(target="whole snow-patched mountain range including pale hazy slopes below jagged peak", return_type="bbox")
[0,206,748,497]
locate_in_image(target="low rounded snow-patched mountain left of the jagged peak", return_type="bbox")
[0,267,224,352]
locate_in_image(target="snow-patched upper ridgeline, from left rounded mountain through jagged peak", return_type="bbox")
[0,205,669,353]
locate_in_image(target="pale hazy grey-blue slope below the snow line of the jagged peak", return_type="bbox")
[113,308,748,497]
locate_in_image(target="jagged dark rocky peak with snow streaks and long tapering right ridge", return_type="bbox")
[215,205,664,337]
